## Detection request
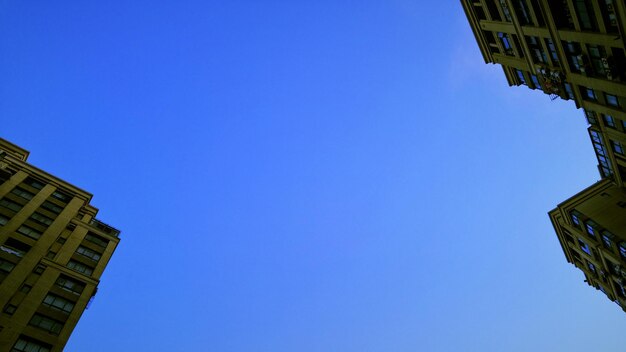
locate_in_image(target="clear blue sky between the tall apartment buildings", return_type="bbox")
[0,0,626,352]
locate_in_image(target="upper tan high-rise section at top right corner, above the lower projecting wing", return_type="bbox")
[461,0,626,185]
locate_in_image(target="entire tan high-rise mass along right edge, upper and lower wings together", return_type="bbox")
[461,0,626,308]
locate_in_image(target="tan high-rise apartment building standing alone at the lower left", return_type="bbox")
[0,139,119,352]
